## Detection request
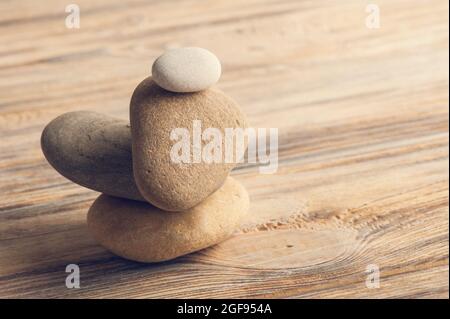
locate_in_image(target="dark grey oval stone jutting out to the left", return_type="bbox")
[41,111,144,200]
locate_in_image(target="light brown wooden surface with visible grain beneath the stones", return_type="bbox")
[0,0,449,298]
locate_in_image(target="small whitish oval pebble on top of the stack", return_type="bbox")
[152,47,222,93]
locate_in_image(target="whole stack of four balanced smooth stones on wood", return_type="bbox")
[41,48,249,262]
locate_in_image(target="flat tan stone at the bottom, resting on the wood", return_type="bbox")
[87,177,249,262]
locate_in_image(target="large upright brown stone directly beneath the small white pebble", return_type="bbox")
[130,78,247,211]
